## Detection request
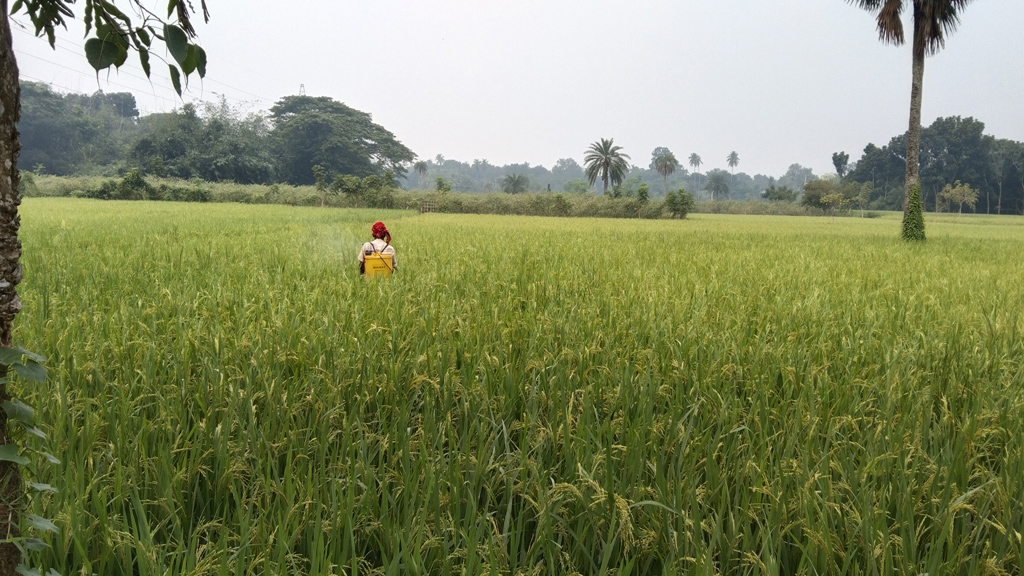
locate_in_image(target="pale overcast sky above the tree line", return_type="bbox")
[13,0,1024,175]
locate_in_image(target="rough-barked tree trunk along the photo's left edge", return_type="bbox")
[0,0,24,576]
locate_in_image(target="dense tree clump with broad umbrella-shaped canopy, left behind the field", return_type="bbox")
[18,82,416,184]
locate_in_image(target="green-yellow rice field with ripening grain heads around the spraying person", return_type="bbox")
[9,199,1024,576]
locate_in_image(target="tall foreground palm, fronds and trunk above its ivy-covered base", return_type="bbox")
[847,0,971,214]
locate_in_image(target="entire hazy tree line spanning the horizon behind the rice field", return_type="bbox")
[18,82,1024,214]
